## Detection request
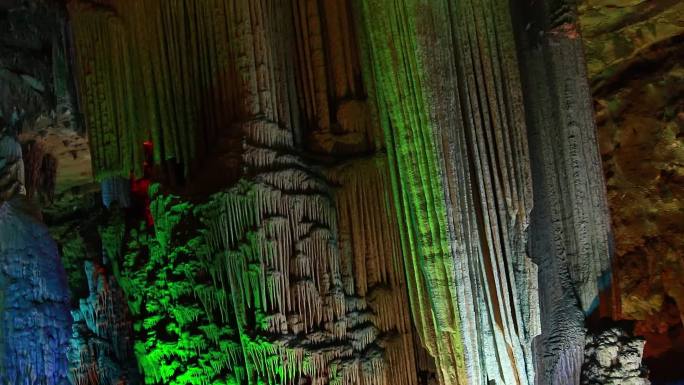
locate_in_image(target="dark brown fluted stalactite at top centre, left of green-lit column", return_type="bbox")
[292,0,383,155]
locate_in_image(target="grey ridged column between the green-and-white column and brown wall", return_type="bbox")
[516,1,612,384]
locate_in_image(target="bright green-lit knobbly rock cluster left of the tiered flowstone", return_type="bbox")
[115,190,245,385]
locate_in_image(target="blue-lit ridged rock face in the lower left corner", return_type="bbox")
[0,137,71,385]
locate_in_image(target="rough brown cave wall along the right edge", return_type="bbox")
[579,1,684,381]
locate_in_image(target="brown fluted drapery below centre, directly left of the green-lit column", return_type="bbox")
[328,156,418,384]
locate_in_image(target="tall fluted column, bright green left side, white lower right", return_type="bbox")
[358,1,539,384]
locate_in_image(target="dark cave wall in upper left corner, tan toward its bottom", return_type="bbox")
[0,0,93,228]
